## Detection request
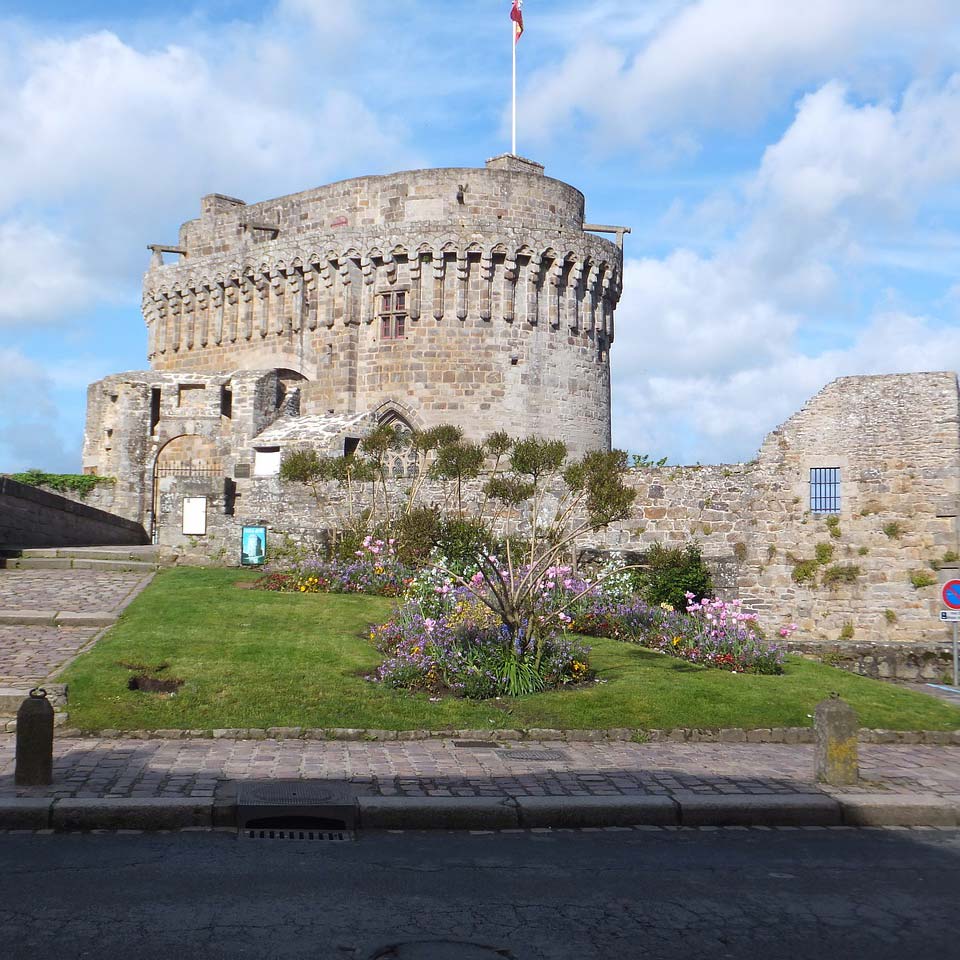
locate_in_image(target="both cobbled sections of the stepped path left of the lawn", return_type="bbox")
[0,570,152,686]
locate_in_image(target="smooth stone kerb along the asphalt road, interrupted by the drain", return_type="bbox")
[0,794,960,832]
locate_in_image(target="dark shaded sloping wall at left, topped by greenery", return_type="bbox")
[0,477,149,551]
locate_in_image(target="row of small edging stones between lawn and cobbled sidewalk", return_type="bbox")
[43,727,960,747]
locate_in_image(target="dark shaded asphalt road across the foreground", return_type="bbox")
[0,829,960,960]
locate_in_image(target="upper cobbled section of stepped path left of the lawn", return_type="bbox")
[0,570,150,613]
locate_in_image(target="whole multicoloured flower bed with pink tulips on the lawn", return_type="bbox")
[260,537,796,699]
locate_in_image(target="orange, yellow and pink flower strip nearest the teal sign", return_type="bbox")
[258,537,413,597]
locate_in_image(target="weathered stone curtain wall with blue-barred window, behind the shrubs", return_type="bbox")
[150,373,960,644]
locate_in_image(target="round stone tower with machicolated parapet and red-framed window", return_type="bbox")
[143,156,622,453]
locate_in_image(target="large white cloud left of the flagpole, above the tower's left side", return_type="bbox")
[0,13,414,325]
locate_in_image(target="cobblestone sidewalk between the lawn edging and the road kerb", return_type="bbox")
[0,735,960,797]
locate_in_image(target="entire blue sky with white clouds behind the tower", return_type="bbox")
[0,0,960,471]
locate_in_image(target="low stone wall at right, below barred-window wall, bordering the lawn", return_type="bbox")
[787,641,953,683]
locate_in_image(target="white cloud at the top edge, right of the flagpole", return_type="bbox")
[523,0,955,150]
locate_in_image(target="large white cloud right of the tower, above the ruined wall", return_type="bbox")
[612,77,960,462]
